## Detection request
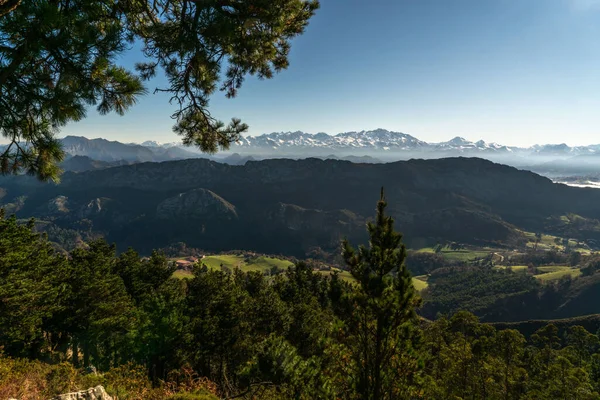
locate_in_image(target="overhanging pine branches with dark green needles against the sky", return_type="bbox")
[0,0,318,180]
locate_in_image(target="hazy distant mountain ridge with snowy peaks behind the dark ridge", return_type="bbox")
[56,129,600,177]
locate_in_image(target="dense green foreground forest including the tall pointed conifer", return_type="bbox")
[0,196,600,399]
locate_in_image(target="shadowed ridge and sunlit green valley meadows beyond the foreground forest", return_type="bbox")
[5,157,600,322]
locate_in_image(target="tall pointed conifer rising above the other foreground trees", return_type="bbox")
[342,188,420,400]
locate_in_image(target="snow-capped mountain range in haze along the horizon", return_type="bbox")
[62,129,600,165]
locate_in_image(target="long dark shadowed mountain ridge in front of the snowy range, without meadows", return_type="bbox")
[0,158,600,256]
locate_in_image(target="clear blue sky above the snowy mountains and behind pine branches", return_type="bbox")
[63,0,600,145]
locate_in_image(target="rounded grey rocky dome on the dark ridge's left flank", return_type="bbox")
[156,188,237,220]
